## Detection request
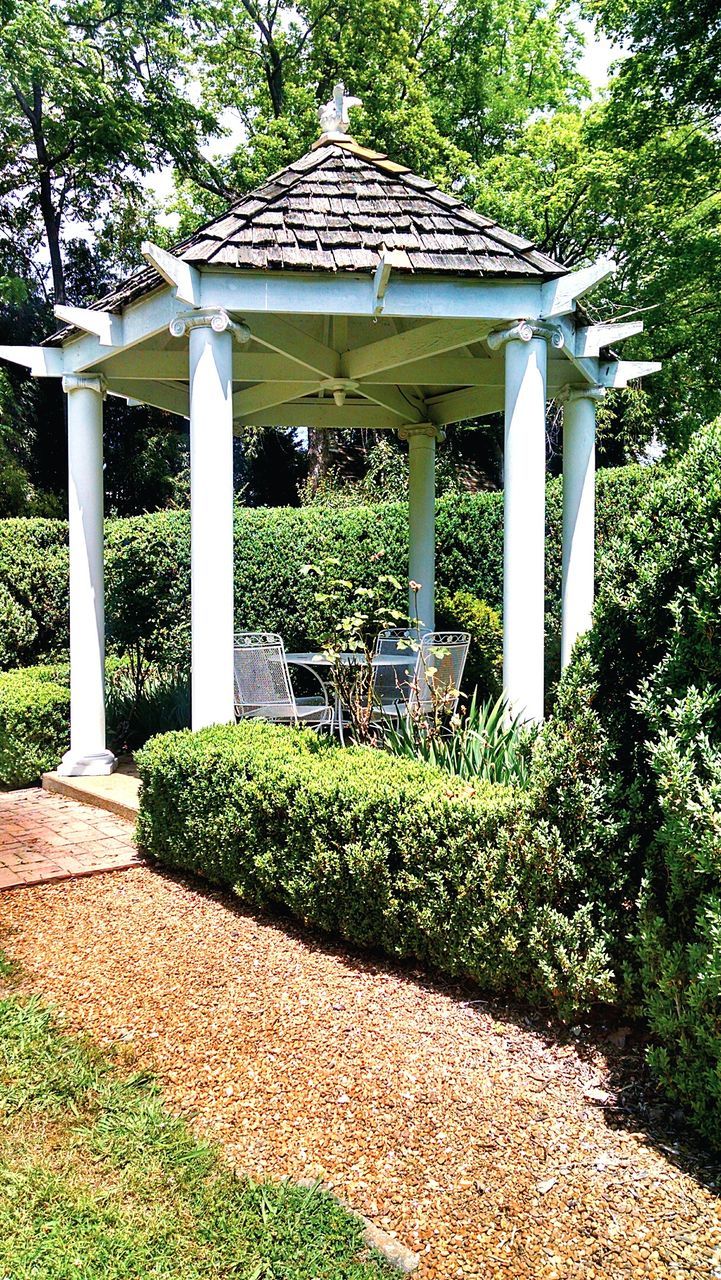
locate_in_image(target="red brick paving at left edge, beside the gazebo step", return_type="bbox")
[0,787,141,890]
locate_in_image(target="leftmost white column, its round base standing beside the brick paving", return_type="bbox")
[58,375,117,777]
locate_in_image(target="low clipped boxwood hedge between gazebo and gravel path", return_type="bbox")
[137,721,612,1012]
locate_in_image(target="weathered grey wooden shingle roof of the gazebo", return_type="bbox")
[53,136,566,342]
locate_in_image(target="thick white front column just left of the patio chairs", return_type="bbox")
[170,311,234,730]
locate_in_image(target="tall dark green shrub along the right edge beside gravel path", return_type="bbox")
[530,422,721,1143]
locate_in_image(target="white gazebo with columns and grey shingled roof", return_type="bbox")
[0,86,660,774]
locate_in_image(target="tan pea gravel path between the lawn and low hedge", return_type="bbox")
[0,868,721,1280]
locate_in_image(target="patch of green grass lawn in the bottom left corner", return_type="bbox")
[0,972,394,1280]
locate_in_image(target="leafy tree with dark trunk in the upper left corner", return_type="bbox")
[0,0,220,302]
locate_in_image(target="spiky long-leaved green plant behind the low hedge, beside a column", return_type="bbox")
[383,692,533,787]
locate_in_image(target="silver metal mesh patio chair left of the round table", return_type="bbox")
[233,631,333,728]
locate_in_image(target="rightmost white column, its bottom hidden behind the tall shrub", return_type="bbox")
[561,387,604,667]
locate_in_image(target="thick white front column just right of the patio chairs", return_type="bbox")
[489,321,562,721]
